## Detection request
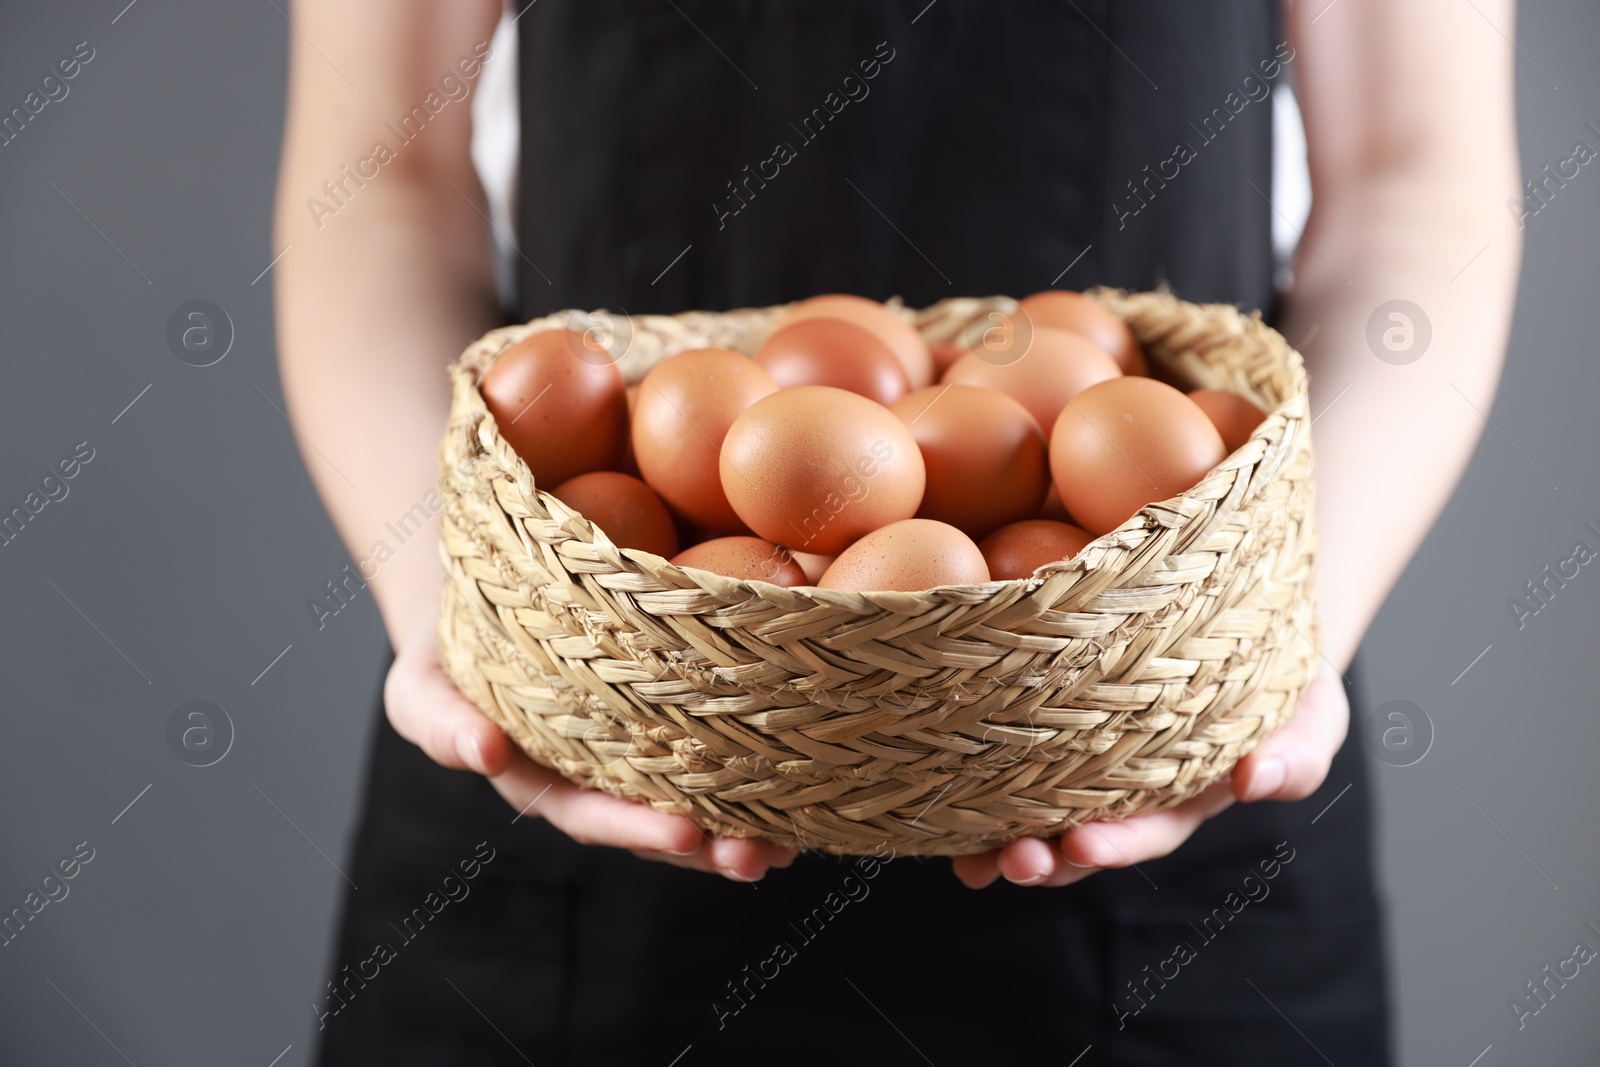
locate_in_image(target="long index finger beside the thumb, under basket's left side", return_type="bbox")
[490,752,704,856]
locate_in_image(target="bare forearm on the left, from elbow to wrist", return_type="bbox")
[275,175,496,641]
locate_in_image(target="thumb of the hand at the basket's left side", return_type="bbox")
[384,621,512,774]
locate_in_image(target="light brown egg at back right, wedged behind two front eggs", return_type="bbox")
[944,326,1122,434]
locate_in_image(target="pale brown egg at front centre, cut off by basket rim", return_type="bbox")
[818,518,989,592]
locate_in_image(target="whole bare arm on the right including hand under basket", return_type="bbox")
[955,0,1522,888]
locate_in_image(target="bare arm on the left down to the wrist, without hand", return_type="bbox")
[274,0,499,646]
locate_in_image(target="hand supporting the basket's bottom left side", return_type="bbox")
[384,611,795,881]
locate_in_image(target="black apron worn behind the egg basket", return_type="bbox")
[312,0,1389,1067]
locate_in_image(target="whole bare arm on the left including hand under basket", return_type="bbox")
[274,0,794,880]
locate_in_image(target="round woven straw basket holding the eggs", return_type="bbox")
[440,290,1317,856]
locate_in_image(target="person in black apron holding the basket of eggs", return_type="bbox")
[275,0,1520,1067]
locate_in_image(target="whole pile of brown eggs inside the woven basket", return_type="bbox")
[482,290,1266,590]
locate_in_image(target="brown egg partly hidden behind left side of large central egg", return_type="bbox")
[632,349,778,533]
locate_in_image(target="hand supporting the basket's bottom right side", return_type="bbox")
[952,665,1350,889]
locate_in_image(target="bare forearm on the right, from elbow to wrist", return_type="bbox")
[1283,185,1522,670]
